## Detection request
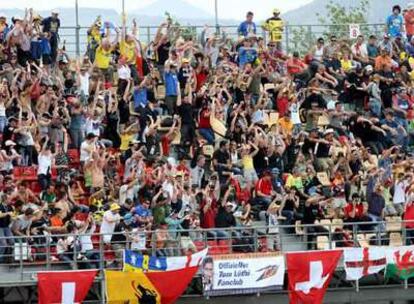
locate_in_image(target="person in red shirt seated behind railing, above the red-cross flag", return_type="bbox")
[344,193,371,230]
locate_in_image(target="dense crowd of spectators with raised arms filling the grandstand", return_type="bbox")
[0,4,414,262]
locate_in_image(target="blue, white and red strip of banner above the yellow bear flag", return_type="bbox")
[123,248,208,272]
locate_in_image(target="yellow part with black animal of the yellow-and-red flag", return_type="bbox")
[105,270,161,304]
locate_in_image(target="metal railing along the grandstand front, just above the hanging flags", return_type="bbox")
[0,217,414,285]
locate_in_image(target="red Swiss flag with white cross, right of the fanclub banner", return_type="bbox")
[286,250,342,304]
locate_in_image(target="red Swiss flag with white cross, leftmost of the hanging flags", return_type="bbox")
[37,270,97,304]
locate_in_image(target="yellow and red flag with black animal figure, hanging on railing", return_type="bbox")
[105,266,198,304]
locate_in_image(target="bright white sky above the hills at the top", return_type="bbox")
[0,0,312,19]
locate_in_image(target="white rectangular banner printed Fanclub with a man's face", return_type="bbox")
[202,253,285,296]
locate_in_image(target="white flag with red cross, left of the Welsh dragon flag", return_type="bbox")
[344,247,387,281]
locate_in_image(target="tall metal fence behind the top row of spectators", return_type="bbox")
[60,23,385,56]
